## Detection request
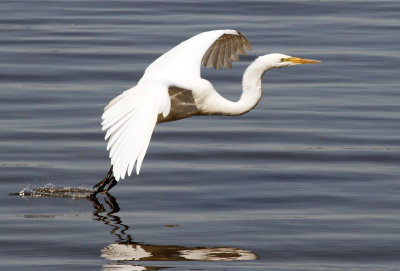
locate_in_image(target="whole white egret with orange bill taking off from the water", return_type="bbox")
[93,30,319,196]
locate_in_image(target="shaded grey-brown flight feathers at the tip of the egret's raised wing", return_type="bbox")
[201,32,251,69]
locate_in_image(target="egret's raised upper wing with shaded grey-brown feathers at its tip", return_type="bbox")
[139,29,251,87]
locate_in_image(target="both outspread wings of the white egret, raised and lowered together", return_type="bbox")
[102,30,251,181]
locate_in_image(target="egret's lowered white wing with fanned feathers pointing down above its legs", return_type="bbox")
[102,85,171,181]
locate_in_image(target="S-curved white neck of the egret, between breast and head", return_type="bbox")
[203,57,272,116]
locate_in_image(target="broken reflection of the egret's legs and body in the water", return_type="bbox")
[90,194,257,270]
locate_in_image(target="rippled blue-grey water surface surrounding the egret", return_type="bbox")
[0,0,400,271]
